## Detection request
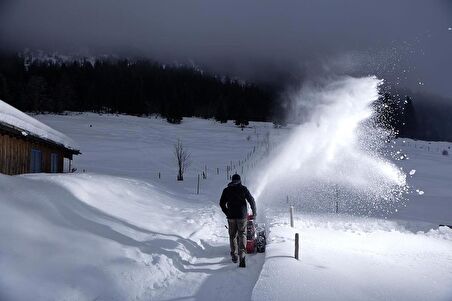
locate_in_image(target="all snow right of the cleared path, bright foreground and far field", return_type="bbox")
[253,139,452,300]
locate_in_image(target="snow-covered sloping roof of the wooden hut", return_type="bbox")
[0,100,79,150]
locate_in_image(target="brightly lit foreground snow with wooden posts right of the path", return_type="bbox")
[253,214,452,300]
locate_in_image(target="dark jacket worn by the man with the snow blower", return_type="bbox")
[220,182,256,219]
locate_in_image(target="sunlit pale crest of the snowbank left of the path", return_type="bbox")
[33,174,205,237]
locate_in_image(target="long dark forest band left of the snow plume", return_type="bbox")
[0,54,277,124]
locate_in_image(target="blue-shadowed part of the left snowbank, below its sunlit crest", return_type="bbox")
[0,176,184,300]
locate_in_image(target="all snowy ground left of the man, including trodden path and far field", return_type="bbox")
[0,114,274,300]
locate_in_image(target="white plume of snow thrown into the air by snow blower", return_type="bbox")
[254,76,407,214]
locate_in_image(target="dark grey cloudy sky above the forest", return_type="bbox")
[0,0,452,99]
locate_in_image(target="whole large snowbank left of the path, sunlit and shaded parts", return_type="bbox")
[0,175,207,300]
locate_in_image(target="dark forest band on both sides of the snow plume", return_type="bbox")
[0,53,452,141]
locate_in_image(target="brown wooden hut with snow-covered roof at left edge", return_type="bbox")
[0,100,80,175]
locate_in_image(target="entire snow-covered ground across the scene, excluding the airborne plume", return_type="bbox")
[0,113,452,300]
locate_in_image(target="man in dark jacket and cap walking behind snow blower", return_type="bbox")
[220,174,256,268]
